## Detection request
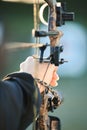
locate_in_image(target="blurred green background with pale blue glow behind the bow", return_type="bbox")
[0,0,87,130]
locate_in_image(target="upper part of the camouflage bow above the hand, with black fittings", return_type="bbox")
[34,0,74,66]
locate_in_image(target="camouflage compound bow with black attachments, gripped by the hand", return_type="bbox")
[34,0,74,130]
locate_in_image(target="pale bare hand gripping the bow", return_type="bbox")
[20,56,59,86]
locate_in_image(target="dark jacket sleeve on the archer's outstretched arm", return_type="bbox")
[0,73,41,130]
